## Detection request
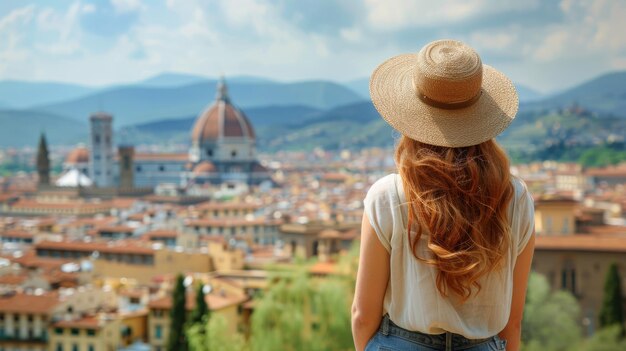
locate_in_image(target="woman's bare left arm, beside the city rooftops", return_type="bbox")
[352,214,389,351]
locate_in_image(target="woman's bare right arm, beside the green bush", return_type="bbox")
[498,230,535,351]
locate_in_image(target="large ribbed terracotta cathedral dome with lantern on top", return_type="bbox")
[191,80,255,144]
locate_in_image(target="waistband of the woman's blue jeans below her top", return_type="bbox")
[379,314,494,350]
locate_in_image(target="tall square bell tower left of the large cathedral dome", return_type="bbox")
[89,112,114,187]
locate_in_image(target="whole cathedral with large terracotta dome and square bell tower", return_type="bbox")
[58,79,271,191]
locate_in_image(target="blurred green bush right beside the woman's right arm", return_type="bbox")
[522,273,581,351]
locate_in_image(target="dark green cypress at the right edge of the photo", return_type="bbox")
[600,263,624,334]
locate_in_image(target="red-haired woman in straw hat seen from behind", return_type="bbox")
[352,40,534,351]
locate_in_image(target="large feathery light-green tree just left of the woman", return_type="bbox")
[251,266,353,351]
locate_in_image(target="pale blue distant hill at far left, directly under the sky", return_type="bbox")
[0,80,96,109]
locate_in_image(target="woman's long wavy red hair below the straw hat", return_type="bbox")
[395,136,514,302]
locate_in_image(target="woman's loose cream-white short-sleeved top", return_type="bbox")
[363,174,534,339]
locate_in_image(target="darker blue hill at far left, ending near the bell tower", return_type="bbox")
[0,110,89,148]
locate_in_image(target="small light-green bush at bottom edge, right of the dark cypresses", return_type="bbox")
[187,314,248,351]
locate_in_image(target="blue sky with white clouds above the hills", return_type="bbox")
[0,0,626,93]
